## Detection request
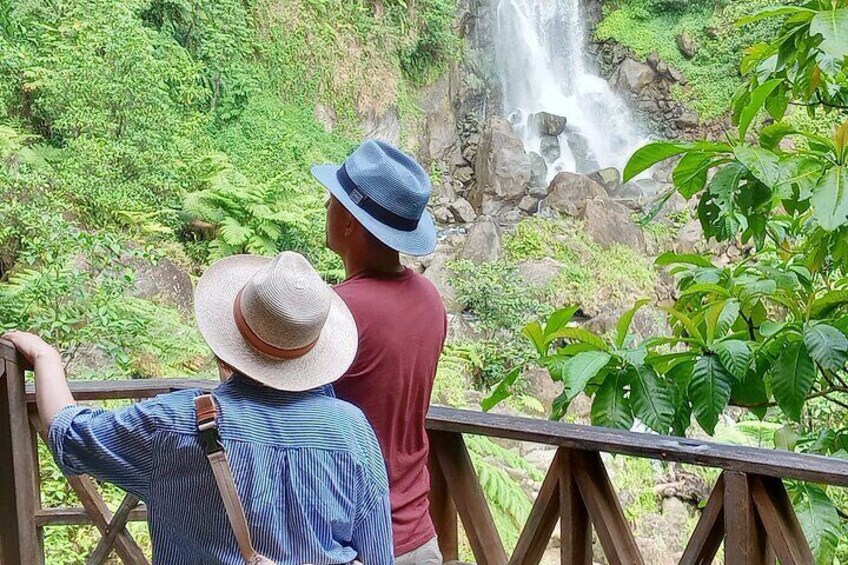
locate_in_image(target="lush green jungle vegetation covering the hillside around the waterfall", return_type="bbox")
[0,0,848,564]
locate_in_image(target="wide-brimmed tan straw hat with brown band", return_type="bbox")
[194,252,359,391]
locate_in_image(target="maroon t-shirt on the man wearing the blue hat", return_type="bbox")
[335,269,447,555]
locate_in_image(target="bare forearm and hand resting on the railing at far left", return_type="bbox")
[2,331,76,430]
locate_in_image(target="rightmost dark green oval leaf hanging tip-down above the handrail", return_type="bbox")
[771,341,816,422]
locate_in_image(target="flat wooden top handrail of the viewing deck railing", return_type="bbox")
[9,372,848,486]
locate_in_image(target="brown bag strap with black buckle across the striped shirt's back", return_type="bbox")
[194,394,270,564]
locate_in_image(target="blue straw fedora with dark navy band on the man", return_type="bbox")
[312,141,436,255]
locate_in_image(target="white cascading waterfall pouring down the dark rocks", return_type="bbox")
[493,0,645,180]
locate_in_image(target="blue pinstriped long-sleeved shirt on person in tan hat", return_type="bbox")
[44,377,394,565]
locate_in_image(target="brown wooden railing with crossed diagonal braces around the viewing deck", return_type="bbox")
[0,341,848,565]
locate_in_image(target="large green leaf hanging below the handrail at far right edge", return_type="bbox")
[793,483,842,565]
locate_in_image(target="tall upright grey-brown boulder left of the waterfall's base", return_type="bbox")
[468,116,530,215]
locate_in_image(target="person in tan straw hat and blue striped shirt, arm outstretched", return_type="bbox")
[3,253,394,565]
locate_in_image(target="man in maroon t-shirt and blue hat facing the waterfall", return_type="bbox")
[312,141,447,565]
